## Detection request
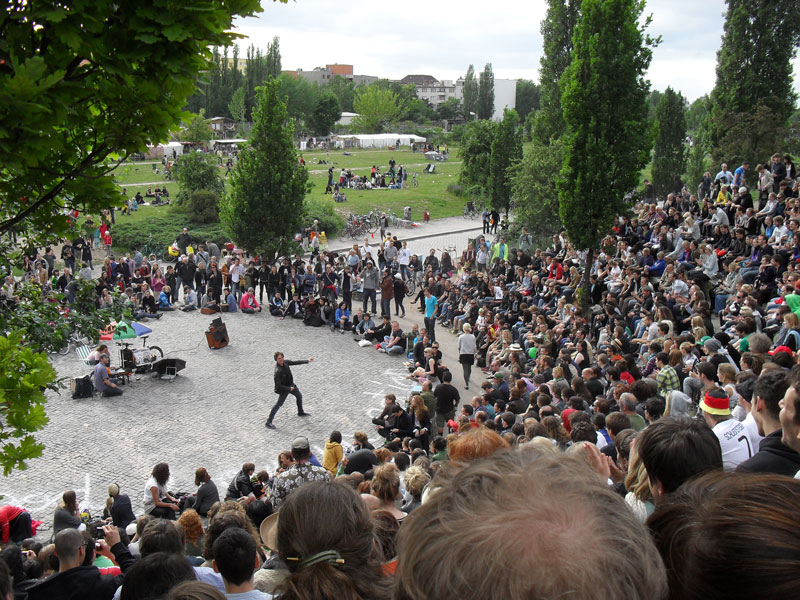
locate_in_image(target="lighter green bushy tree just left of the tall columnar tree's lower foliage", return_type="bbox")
[510,138,564,246]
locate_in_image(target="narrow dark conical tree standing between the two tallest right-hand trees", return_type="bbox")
[653,87,686,198]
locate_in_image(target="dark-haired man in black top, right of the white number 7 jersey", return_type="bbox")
[736,369,800,477]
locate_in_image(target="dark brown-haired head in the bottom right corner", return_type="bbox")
[647,471,800,600]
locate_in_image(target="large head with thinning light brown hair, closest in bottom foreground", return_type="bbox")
[390,447,667,600]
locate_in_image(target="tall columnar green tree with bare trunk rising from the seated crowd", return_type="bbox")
[558,0,657,308]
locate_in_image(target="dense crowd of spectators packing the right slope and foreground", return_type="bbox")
[0,155,800,600]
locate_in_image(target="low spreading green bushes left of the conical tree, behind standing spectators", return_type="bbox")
[111,206,230,256]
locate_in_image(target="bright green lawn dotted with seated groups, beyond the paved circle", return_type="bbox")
[108,148,466,221]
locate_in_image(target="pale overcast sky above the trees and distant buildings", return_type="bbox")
[228,0,800,101]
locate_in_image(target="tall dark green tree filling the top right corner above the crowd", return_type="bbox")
[710,0,800,164]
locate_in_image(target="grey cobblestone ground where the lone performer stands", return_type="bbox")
[0,222,480,537]
